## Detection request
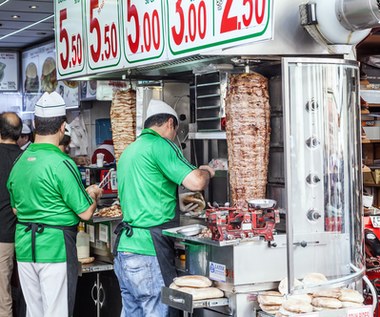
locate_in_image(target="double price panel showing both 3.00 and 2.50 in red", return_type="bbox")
[166,0,272,56]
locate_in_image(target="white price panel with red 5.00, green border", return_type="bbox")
[122,0,165,63]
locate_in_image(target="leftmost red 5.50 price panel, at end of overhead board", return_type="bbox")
[55,0,85,79]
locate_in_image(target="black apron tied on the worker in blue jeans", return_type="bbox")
[113,212,180,317]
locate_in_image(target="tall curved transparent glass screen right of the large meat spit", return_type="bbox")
[282,58,364,292]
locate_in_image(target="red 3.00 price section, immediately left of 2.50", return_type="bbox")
[166,0,215,54]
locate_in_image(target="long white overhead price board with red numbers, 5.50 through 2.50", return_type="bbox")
[55,0,273,79]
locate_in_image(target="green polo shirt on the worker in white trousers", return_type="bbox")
[7,143,92,263]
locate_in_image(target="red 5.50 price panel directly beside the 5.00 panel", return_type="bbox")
[85,0,121,73]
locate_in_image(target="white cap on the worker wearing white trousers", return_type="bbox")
[34,91,66,118]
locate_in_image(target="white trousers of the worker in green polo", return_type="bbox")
[17,262,69,317]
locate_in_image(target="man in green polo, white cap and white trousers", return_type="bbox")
[7,92,102,317]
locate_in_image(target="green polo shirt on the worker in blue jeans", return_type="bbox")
[117,129,196,255]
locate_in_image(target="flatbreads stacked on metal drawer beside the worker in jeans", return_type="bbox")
[169,275,224,301]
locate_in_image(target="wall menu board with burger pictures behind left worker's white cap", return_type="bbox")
[22,42,79,112]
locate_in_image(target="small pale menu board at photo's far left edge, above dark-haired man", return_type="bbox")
[0,52,19,91]
